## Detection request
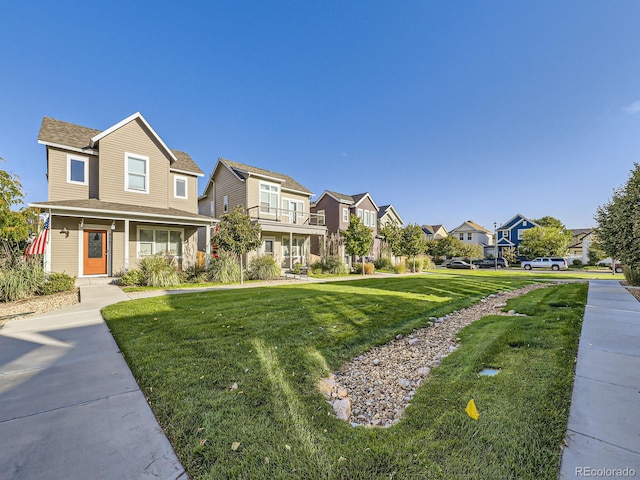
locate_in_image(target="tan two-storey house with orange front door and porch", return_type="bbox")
[31,113,211,277]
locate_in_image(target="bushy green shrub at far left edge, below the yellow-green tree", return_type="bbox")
[0,253,46,302]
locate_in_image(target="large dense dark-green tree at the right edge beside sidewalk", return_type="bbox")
[594,163,640,282]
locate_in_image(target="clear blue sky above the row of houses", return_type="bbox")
[0,0,640,229]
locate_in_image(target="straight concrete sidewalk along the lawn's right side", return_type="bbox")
[560,280,640,479]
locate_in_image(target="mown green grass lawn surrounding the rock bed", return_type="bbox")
[103,275,587,479]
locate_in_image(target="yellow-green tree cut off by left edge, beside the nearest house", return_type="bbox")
[0,158,38,250]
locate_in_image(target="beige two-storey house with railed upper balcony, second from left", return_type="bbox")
[198,158,327,268]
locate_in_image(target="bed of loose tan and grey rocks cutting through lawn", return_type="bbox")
[319,284,548,427]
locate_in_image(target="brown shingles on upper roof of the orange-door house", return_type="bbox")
[38,117,202,174]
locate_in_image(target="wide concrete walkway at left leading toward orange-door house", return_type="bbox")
[0,285,187,480]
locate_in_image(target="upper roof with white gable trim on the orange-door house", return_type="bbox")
[38,112,203,176]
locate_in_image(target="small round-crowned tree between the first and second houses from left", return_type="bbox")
[213,205,261,284]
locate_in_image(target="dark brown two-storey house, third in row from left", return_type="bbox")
[311,190,380,265]
